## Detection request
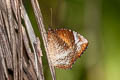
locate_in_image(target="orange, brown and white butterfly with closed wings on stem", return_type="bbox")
[47,29,88,69]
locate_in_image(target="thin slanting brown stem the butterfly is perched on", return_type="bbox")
[31,0,56,80]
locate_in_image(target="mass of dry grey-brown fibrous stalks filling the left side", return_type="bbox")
[0,0,44,80]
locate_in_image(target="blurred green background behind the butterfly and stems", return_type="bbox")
[24,0,120,80]
